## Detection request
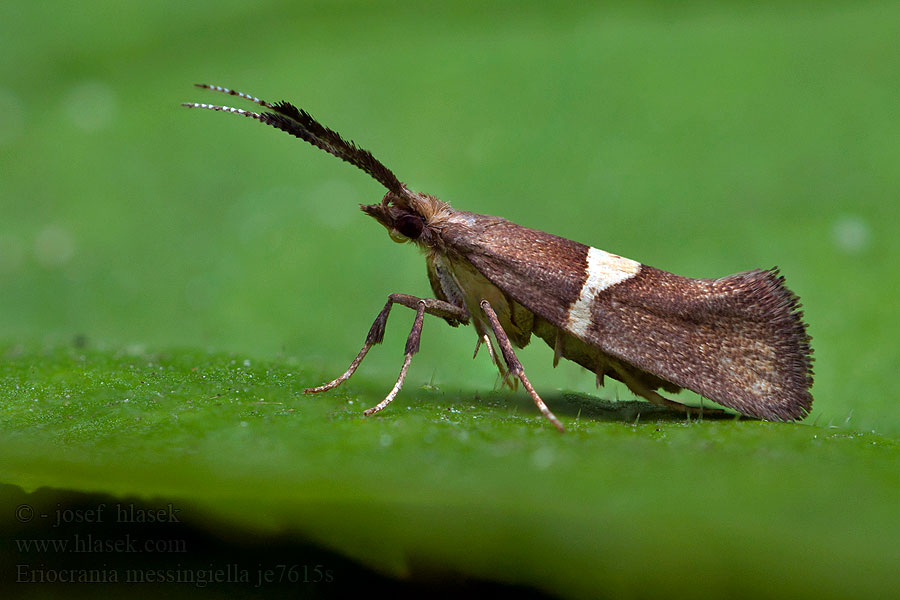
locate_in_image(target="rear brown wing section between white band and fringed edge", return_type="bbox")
[584,265,812,420]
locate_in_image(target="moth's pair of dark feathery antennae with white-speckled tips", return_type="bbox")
[182,83,412,199]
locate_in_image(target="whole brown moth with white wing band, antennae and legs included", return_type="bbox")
[183,84,813,431]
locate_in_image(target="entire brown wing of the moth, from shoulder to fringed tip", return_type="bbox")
[445,220,812,420]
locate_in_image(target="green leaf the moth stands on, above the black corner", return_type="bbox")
[0,347,900,598]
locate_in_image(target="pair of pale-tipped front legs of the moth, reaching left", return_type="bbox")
[303,294,469,416]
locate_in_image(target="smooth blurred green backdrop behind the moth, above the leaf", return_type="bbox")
[0,1,900,433]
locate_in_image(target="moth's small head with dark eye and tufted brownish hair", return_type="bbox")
[360,188,451,245]
